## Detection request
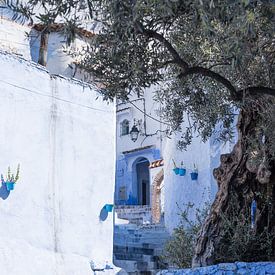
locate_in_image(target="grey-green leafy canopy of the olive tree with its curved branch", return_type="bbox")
[78,0,275,149]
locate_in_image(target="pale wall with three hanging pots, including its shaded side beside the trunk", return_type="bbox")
[164,121,237,233]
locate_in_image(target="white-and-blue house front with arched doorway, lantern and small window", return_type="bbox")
[115,88,165,210]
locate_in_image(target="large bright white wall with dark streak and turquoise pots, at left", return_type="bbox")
[0,52,115,275]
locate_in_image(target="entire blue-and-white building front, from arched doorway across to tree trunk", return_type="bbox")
[115,87,234,233]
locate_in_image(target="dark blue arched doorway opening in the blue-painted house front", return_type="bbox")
[133,158,150,205]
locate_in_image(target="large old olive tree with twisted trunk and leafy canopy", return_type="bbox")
[2,0,275,266]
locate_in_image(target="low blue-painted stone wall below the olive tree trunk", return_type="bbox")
[158,262,275,275]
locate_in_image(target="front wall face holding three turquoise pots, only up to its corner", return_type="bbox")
[164,132,211,232]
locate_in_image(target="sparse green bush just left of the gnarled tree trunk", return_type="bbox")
[162,203,209,268]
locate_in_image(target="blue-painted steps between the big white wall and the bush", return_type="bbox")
[114,225,169,275]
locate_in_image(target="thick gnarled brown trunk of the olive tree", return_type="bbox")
[192,104,275,267]
